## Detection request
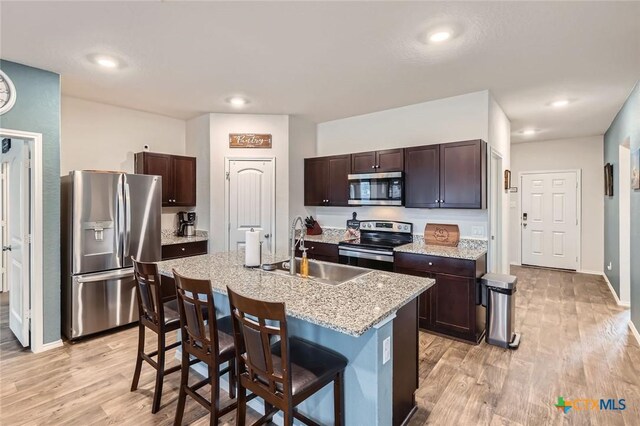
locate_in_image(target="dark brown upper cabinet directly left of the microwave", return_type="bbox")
[304,155,351,206]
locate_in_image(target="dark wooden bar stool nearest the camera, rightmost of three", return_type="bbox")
[227,287,347,426]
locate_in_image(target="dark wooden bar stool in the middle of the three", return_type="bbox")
[173,269,238,425]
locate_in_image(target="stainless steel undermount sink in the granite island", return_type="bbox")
[262,258,373,285]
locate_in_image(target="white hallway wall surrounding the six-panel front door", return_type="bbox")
[509,136,604,273]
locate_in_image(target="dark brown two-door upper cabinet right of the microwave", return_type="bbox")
[405,140,487,209]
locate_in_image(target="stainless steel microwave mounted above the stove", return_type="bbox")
[348,172,404,206]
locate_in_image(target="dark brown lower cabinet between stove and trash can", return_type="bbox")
[395,253,486,343]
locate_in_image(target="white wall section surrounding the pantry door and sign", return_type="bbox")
[209,114,289,253]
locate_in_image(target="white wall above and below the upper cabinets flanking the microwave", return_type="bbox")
[316,91,502,238]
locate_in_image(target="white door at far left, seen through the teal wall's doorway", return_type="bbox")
[2,139,31,346]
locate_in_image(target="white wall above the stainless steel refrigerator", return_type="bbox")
[60,96,186,229]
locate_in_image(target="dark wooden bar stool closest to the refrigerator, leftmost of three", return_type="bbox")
[131,257,189,414]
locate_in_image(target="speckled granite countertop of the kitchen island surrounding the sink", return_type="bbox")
[158,251,435,337]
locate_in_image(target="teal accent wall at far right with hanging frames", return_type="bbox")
[604,82,640,328]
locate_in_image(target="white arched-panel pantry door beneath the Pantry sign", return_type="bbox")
[227,160,275,254]
